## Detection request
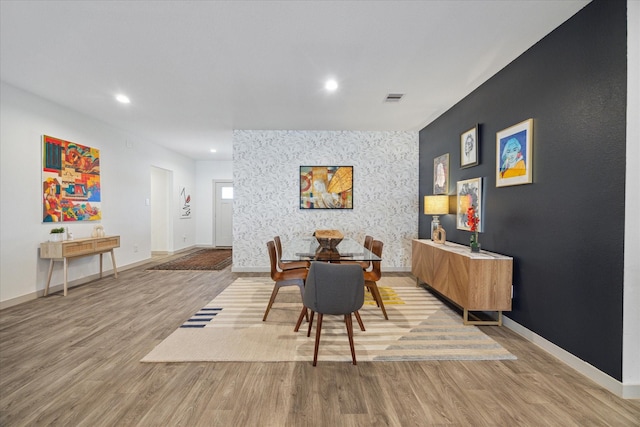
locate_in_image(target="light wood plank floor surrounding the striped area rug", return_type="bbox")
[0,256,640,426]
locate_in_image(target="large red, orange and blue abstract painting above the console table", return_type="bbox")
[42,135,102,222]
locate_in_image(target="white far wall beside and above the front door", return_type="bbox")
[194,160,233,246]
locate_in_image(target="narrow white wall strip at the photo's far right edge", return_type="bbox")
[622,0,640,398]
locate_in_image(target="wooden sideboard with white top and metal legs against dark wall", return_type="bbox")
[411,239,513,325]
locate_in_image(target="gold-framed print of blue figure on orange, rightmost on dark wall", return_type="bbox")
[496,119,533,187]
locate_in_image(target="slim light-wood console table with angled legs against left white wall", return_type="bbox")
[40,236,120,296]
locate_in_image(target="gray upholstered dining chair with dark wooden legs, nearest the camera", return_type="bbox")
[298,262,364,366]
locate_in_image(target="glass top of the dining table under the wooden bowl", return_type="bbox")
[281,236,382,262]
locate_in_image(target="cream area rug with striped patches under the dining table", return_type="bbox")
[142,277,516,362]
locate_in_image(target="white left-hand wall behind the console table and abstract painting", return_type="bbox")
[0,82,196,303]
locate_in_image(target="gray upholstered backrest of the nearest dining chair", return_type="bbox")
[304,261,364,314]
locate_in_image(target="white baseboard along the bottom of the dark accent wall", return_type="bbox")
[502,316,640,399]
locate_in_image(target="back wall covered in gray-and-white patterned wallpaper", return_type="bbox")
[233,130,419,272]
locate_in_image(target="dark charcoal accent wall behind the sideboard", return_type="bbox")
[419,0,627,381]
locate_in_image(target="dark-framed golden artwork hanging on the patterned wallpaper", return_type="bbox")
[300,166,353,209]
